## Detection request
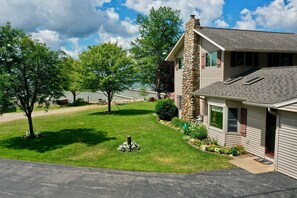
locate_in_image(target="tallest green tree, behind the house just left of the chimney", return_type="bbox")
[131,7,182,98]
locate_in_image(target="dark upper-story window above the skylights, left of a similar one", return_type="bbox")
[231,52,259,67]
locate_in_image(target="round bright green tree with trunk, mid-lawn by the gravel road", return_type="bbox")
[80,43,135,112]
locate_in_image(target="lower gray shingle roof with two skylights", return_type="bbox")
[193,66,297,104]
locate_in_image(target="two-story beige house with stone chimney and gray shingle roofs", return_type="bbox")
[166,16,297,179]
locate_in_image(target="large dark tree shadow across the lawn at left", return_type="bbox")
[0,128,116,153]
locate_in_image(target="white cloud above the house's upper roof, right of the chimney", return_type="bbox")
[237,0,297,33]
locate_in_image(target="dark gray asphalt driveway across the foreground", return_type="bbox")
[0,159,297,198]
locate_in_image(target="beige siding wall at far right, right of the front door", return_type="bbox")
[277,111,297,179]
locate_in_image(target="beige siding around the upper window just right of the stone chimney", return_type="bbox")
[200,38,224,88]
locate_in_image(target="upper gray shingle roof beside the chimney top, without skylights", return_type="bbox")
[196,27,297,52]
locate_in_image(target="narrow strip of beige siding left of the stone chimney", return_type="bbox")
[174,48,184,117]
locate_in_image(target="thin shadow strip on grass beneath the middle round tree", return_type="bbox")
[89,109,154,116]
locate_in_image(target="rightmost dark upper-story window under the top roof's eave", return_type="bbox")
[267,53,293,67]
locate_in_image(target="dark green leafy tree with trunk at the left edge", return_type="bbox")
[0,23,63,137]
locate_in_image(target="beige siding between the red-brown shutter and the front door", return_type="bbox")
[242,106,266,158]
